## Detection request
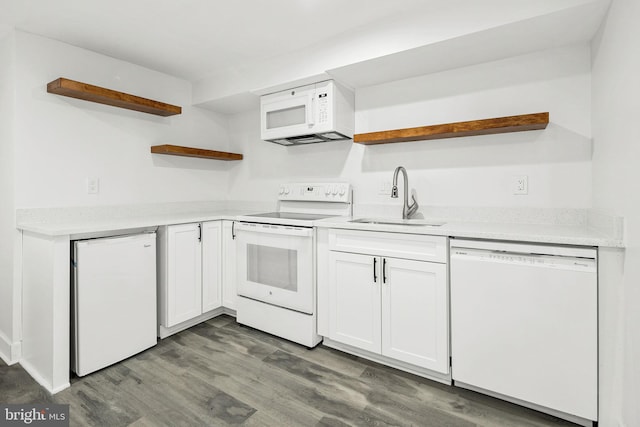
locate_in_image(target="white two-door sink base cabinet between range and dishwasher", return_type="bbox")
[328,230,449,374]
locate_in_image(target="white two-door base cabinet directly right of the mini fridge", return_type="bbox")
[158,221,222,338]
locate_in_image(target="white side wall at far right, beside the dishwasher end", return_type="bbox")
[592,0,640,427]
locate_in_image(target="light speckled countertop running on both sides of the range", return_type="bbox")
[17,202,624,248]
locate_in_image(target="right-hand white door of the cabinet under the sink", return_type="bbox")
[382,258,449,374]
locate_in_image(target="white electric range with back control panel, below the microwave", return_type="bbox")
[235,182,352,347]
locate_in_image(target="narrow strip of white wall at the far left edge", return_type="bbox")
[0,33,19,362]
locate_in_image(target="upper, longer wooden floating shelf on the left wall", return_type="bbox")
[47,77,182,117]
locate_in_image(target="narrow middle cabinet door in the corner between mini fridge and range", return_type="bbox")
[202,221,222,313]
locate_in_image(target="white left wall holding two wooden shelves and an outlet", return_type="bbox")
[15,32,232,208]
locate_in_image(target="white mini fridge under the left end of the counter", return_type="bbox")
[71,233,157,376]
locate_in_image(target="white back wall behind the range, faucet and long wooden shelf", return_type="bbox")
[230,44,592,212]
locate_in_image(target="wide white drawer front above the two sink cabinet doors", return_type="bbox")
[329,230,447,263]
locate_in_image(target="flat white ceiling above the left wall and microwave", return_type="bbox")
[0,0,442,81]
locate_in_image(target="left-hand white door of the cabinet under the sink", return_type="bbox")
[329,251,381,354]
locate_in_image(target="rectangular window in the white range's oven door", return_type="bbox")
[247,244,298,292]
